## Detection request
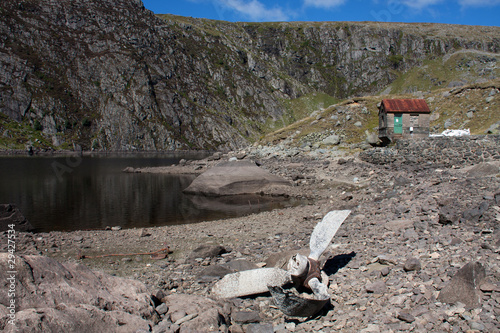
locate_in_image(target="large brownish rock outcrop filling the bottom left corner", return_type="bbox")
[0,253,157,332]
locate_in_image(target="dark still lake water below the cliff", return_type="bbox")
[0,153,296,232]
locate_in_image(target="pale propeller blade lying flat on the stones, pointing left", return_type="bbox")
[212,268,292,298]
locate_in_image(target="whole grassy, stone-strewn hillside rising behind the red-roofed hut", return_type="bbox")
[261,50,500,145]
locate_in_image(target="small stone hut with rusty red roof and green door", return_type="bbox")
[378,99,431,142]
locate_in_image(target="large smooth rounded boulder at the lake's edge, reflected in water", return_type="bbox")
[184,161,290,196]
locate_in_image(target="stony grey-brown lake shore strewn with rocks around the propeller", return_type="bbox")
[1,137,500,332]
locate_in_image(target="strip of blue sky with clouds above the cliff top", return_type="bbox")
[143,0,500,26]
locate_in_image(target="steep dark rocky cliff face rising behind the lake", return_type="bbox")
[0,0,500,150]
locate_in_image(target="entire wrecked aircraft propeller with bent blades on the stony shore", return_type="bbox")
[212,210,351,317]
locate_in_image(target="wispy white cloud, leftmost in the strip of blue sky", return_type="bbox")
[217,0,289,21]
